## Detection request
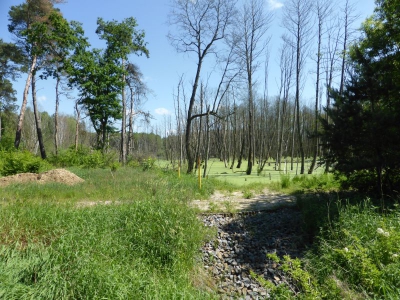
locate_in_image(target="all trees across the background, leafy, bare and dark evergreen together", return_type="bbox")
[0,0,400,194]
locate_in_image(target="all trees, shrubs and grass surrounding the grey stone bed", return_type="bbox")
[0,0,400,299]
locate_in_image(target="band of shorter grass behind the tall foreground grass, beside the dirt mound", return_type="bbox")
[0,167,214,203]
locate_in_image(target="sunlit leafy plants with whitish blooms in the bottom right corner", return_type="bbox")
[308,201,400,299]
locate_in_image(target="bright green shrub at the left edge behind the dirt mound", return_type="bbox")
[0,151,51,176]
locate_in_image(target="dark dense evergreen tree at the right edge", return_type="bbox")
[324,0,400,197]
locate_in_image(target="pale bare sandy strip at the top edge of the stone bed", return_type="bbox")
[191,189,296,213]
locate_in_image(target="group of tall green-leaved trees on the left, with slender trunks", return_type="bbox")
[0,0,149,162]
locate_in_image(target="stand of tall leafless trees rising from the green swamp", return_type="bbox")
[169,0,357,174]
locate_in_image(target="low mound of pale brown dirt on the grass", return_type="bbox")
[0,169,84,186]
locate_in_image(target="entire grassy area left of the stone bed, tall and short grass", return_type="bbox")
[0,168,219,299]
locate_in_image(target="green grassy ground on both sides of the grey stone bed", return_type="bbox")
[0,161,400,299]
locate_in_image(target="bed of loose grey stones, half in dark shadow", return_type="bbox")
[200,208,307,300]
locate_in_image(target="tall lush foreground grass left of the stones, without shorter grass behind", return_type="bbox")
[0,200,212,299]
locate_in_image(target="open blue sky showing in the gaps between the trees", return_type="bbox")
[0,0,374,131]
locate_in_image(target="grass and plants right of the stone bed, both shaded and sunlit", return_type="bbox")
[260,174,400,300]
